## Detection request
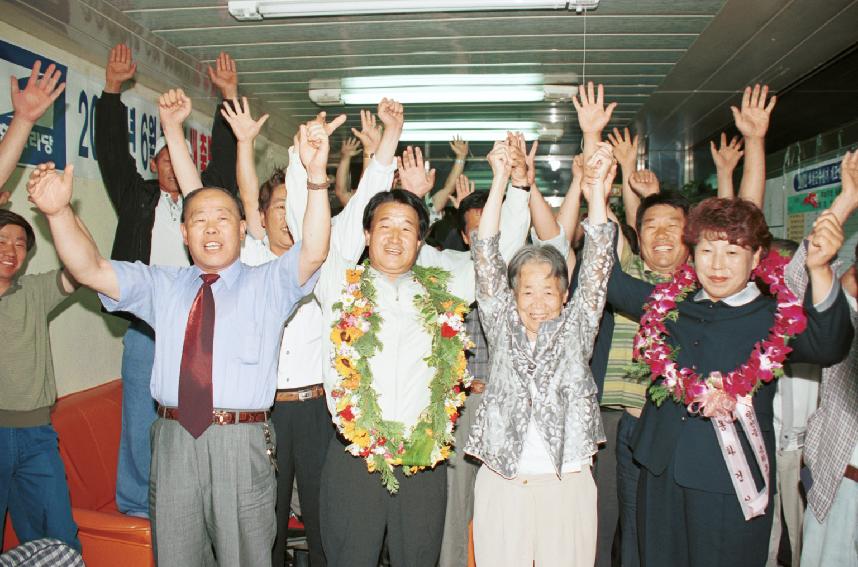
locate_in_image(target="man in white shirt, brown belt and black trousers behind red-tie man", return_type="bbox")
[224,98,344,567]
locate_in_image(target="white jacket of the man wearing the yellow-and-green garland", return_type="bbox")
[286,148,530,428]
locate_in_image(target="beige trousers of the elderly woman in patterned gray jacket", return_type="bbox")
[474,466,597,567]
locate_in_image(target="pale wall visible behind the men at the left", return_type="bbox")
[0,22,287,396]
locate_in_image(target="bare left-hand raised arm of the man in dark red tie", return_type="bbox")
[27,163,119,300]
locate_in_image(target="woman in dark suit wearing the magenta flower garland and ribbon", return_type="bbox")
[608,198,852,567]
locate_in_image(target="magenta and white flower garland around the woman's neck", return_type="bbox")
[632,253,807,417]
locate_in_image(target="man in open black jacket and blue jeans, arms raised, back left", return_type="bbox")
[95,44,238,517]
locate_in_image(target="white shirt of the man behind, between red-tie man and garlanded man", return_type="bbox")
[241,234,322,389]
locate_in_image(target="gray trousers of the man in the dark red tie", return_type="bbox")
[149,418,277,567]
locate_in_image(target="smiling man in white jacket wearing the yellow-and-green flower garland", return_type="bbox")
[286,105,530,567]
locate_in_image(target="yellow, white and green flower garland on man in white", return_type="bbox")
[331,264,473,494]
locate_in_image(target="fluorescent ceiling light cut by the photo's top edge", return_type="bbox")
[229,0,599,21]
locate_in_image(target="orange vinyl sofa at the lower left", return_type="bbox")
[3,380,155,567]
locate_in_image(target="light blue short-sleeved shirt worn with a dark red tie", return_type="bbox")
[99,243,318,410]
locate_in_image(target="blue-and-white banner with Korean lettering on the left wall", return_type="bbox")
[0,40,211,182]
